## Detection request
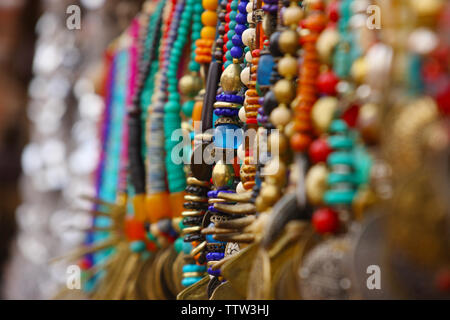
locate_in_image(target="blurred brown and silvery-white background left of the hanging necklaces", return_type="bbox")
[0,0,142,299]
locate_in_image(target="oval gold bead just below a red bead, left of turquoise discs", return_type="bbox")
[305,163,328,205]
